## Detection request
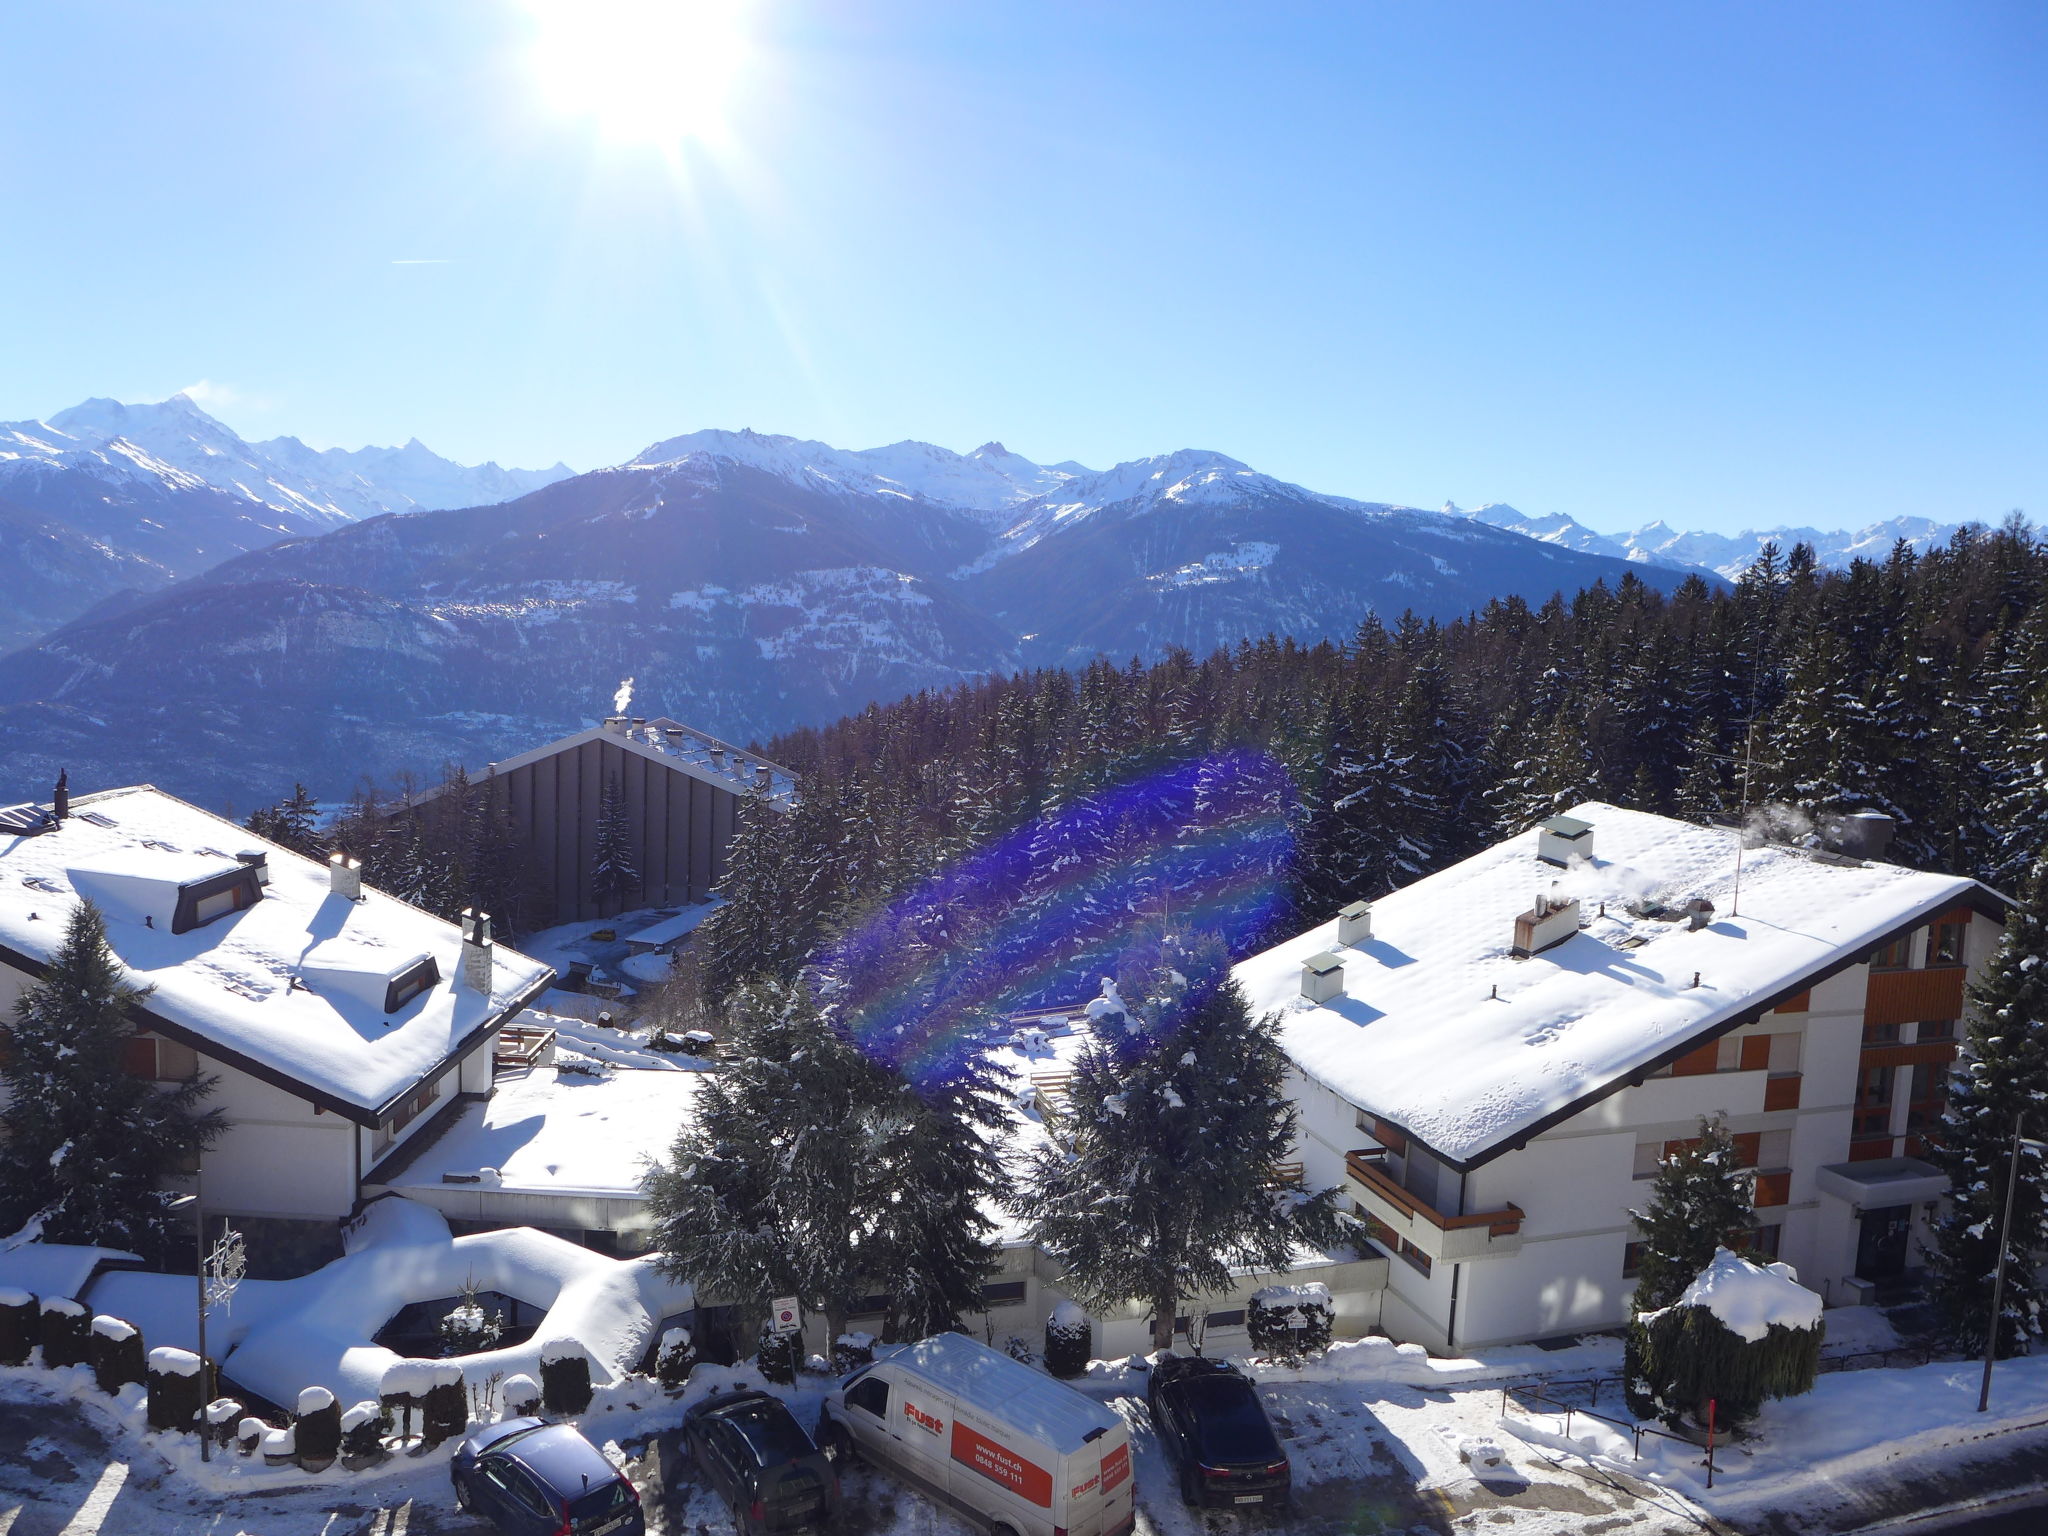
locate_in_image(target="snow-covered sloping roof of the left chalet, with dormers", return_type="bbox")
[0,784,553,1122]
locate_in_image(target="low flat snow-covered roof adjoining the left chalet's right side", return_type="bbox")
[371,1067,705,1200]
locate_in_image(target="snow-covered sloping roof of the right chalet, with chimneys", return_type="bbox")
[1235,803,1999,1165]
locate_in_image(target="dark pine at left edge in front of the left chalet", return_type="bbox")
[0,901,223,1255]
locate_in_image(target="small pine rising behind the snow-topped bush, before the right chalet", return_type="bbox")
[1622,1116,1755,1417]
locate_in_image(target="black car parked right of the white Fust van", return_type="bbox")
[1145,1356,1292,1509]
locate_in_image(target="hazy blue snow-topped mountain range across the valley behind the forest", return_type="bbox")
[0,399,1998,807]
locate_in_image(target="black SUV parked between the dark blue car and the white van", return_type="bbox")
[682,1389,840,1536]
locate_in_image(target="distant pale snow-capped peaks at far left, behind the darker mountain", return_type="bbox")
[0,393,571,649]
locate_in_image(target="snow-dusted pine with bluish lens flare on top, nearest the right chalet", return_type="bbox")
[1018,940,1339,1350]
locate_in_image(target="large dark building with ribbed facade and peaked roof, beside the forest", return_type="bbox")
[492,715,797,924]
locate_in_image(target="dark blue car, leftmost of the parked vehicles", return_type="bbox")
[449,1419,647,1536]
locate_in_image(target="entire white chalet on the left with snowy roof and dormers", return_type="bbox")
[0,786,555,1274]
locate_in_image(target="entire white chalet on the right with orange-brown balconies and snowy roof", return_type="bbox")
[1237,803,2005,1350]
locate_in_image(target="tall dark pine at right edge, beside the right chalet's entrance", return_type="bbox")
[1927,864,2048,1354]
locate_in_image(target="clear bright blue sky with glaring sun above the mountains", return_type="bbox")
[0,0,2048,528]
